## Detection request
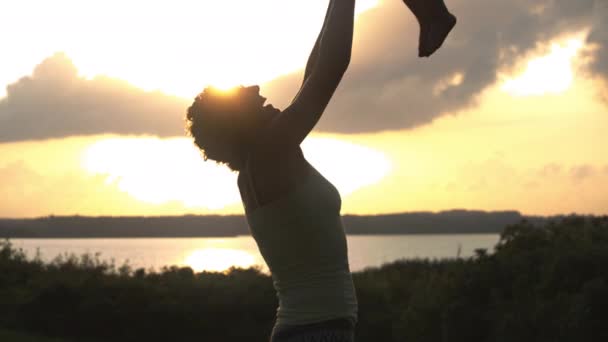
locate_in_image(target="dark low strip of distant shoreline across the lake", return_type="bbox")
[0,210,547,239]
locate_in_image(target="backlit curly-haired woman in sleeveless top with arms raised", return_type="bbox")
[187,0,451,342]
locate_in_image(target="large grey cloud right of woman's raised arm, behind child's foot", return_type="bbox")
[265,0,608,133]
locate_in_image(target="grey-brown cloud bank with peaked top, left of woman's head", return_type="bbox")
[0,54,187,142]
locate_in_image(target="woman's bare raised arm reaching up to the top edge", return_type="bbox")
[264,0,355,149]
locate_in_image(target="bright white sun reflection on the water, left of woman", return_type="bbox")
[184,248,255,272]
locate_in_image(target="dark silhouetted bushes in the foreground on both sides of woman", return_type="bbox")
[0,216,608,342]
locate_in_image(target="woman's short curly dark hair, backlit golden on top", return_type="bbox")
[186,86,265,171]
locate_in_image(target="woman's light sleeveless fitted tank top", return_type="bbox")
[246,168,357,326]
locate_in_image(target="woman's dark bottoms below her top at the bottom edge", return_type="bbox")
[270,319,355,342]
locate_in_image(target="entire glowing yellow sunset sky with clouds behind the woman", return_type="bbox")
[0,0,608,217]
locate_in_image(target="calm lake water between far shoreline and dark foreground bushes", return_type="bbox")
[11,234,499,271]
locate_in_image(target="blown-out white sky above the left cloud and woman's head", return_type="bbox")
[0,0,378,97]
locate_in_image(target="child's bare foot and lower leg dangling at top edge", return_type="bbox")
[403,0,456,57]
